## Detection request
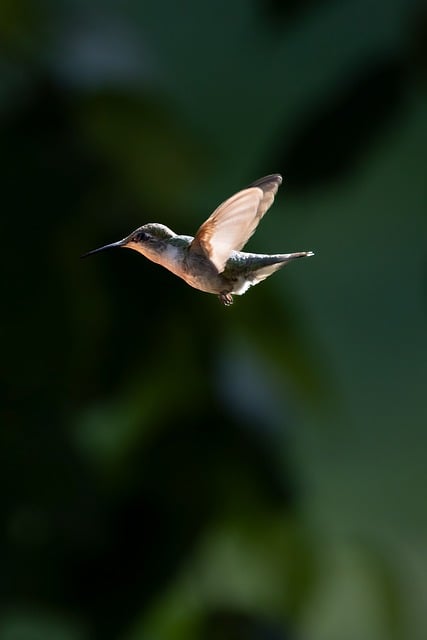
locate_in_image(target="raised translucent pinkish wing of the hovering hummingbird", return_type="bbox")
[190,174,282,273]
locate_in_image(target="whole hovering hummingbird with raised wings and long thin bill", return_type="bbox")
[82,173,314,306]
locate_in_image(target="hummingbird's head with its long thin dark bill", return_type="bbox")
[82,222,175,262]
